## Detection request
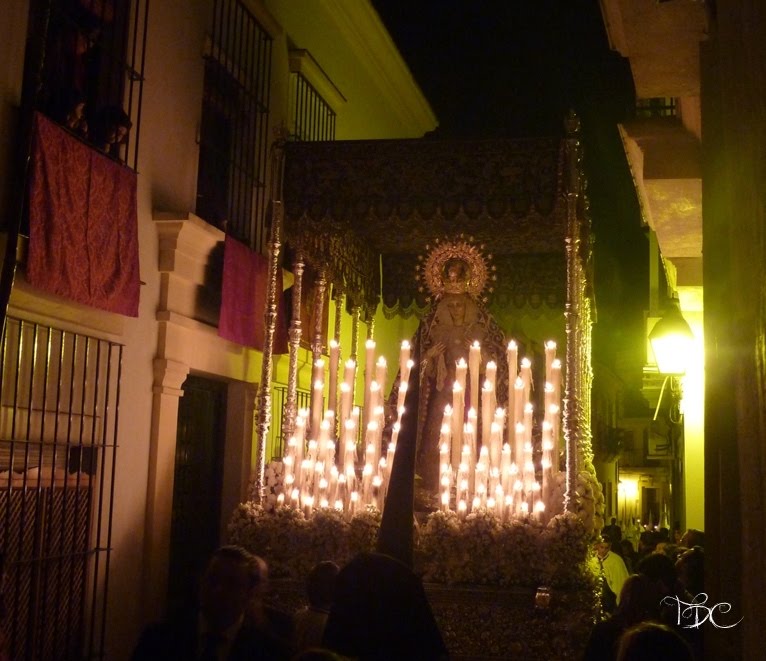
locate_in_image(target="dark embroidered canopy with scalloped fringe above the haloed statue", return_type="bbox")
[283,138,567,315]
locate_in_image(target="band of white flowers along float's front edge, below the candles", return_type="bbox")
[228,502,591,587]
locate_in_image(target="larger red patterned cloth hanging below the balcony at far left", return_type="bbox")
[27,113,141,317]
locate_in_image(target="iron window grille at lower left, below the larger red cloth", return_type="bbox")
[0,317,123,659]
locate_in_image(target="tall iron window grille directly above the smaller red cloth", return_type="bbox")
[197,0,272,252]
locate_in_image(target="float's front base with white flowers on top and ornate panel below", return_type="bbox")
[229,502,598,661]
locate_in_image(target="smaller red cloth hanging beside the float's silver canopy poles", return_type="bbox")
[218,236,288,354]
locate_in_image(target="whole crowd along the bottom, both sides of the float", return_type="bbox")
[132,522,704,661]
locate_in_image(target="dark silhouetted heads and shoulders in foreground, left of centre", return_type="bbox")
[131,546,448,661]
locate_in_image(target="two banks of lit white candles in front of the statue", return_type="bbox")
[278,340,561,521]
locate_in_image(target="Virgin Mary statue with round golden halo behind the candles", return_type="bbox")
[388,239,508,494]
